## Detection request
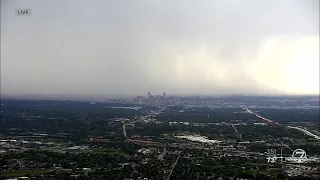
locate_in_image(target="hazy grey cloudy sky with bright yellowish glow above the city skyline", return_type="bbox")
[1,0,319,97]
